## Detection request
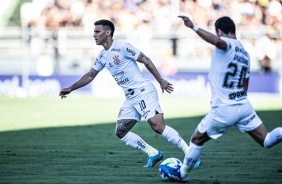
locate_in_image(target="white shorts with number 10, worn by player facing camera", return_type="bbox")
[117,84,163,122]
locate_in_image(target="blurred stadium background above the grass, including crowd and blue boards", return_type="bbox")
[0,0,282,98]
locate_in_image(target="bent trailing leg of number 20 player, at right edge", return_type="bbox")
[248,124,282,148]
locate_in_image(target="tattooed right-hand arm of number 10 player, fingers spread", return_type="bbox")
[137,52,173,93]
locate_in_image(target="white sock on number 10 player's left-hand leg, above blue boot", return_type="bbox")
[120,132,159,156]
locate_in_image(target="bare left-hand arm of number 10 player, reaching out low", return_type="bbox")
[59,68,99,99]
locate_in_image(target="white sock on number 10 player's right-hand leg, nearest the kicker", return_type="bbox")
[162,125,188,153]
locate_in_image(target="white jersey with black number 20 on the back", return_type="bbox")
[208,37,250,107]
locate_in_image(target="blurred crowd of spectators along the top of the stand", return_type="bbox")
[24,0,282,30]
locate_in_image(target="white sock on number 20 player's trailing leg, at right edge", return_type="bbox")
[263,127,282,148]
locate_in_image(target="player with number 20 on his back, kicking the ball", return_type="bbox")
[163,16,282,181]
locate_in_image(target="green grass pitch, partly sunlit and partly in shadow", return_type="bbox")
[0,95,282,184]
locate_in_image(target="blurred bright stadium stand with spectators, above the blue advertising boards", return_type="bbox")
[0,0,282,75]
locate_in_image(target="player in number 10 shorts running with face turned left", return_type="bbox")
[60,20,200,167]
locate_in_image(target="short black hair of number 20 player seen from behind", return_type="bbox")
[214,17,236,34]
